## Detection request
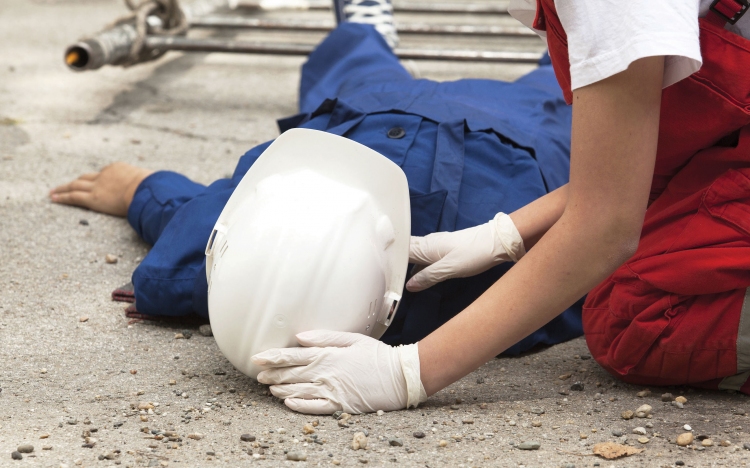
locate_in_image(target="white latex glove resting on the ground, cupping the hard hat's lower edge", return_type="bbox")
[252,330,427,414]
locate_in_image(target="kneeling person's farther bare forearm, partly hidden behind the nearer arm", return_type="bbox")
[510,184,568,251]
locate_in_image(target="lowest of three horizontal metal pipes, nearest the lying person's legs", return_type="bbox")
[146,36,541,63]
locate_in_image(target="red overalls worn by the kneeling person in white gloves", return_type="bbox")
[535,0,750,393]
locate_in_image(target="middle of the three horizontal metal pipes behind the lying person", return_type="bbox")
[190,16,538,37]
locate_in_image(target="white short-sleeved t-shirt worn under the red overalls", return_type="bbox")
[508,0,750,89]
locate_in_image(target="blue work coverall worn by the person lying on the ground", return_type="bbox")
[128,23,582,354]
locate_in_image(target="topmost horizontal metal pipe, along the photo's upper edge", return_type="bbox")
[234,0,508,15]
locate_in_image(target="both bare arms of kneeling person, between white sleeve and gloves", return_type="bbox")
[419,57,664,394]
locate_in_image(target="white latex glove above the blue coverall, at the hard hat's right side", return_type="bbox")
[406,213,526,292]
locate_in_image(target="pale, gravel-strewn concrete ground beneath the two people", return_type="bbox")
[0,0,750,467]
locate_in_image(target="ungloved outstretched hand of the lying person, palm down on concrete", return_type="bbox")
[49,162,152,217]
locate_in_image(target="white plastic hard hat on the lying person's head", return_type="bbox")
[206,129,411,378]
